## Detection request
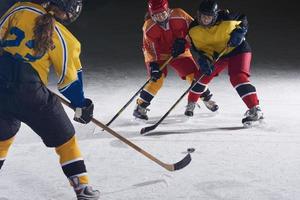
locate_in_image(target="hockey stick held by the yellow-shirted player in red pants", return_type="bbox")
[140,47,227,135]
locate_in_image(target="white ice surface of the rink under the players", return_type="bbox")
[0,64,300,200]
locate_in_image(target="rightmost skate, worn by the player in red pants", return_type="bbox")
[242,106,264,128]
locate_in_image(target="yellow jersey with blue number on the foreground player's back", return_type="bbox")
[0,2,81,90]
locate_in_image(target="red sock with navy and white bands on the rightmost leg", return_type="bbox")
[230,73,259,108]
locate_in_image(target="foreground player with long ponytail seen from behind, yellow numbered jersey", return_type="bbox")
[0,0,100,200]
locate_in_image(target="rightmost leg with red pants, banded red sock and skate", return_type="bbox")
[228,52,263,123]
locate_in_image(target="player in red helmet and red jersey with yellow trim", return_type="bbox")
[133,0,218,120]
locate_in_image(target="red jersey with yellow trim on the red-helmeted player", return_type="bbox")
[143,8,193,62]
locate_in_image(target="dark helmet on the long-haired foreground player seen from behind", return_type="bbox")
[48,0,82,24]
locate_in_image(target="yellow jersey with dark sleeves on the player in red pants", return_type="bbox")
[188,10,251,59]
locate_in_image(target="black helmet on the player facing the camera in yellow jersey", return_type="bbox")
[197,0,219,26]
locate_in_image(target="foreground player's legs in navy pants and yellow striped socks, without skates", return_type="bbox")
[0,52,88,186]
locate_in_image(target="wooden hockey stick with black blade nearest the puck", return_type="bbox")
[53,93,192,171]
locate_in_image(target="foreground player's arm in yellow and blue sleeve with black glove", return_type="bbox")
[50,26,94,123]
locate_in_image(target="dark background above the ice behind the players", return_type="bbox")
[0,0,300,70]
